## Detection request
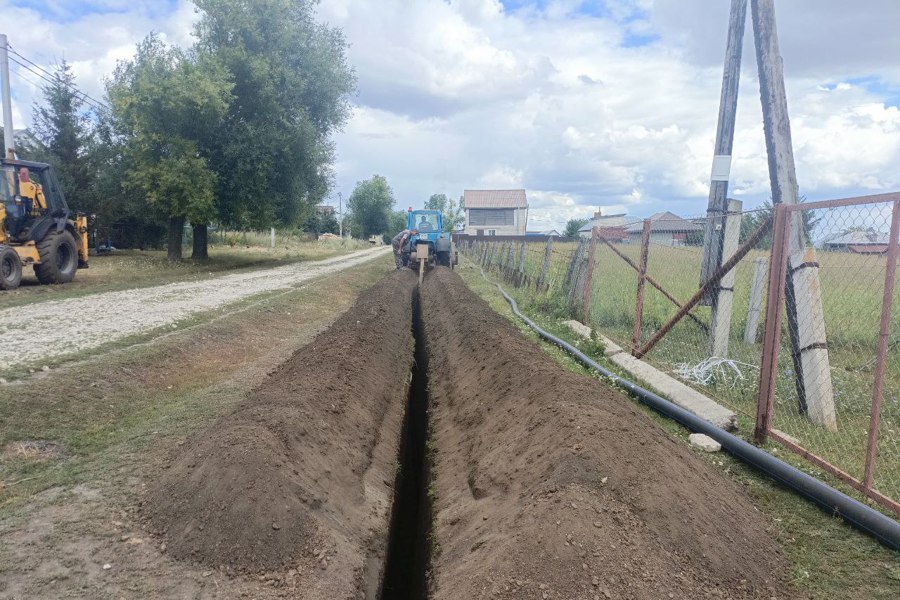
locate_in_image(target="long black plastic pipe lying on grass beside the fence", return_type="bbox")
[481,271,900,550]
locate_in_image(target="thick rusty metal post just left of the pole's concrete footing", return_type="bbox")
[753,205,791,444]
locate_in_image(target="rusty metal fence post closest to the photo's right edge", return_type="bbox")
[863,200,900,488]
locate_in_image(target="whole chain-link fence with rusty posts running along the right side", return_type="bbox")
[460,194,900,513]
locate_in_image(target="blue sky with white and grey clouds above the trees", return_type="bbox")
[0,0,900,229]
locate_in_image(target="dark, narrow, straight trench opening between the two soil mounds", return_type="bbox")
[378,289,431,600]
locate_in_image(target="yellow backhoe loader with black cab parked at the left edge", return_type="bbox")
[0,158,88,290]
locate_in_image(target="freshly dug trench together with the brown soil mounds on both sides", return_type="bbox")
[141,268,791,600]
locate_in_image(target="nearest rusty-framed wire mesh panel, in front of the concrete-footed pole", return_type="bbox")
[772,203,900,508]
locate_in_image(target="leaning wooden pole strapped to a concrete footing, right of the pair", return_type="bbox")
[750,0,837,430]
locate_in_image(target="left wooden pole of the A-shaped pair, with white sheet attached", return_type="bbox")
[700,0,747,304]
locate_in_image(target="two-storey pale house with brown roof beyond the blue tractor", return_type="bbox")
[463,190,528,235]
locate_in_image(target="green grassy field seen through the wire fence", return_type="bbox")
[468,242,900,510]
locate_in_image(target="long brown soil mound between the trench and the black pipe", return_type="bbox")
[422,269,786,599]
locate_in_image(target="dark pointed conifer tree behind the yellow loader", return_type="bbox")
[32,61,94,212]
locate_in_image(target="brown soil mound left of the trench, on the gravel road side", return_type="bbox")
[142,271,416,598]
